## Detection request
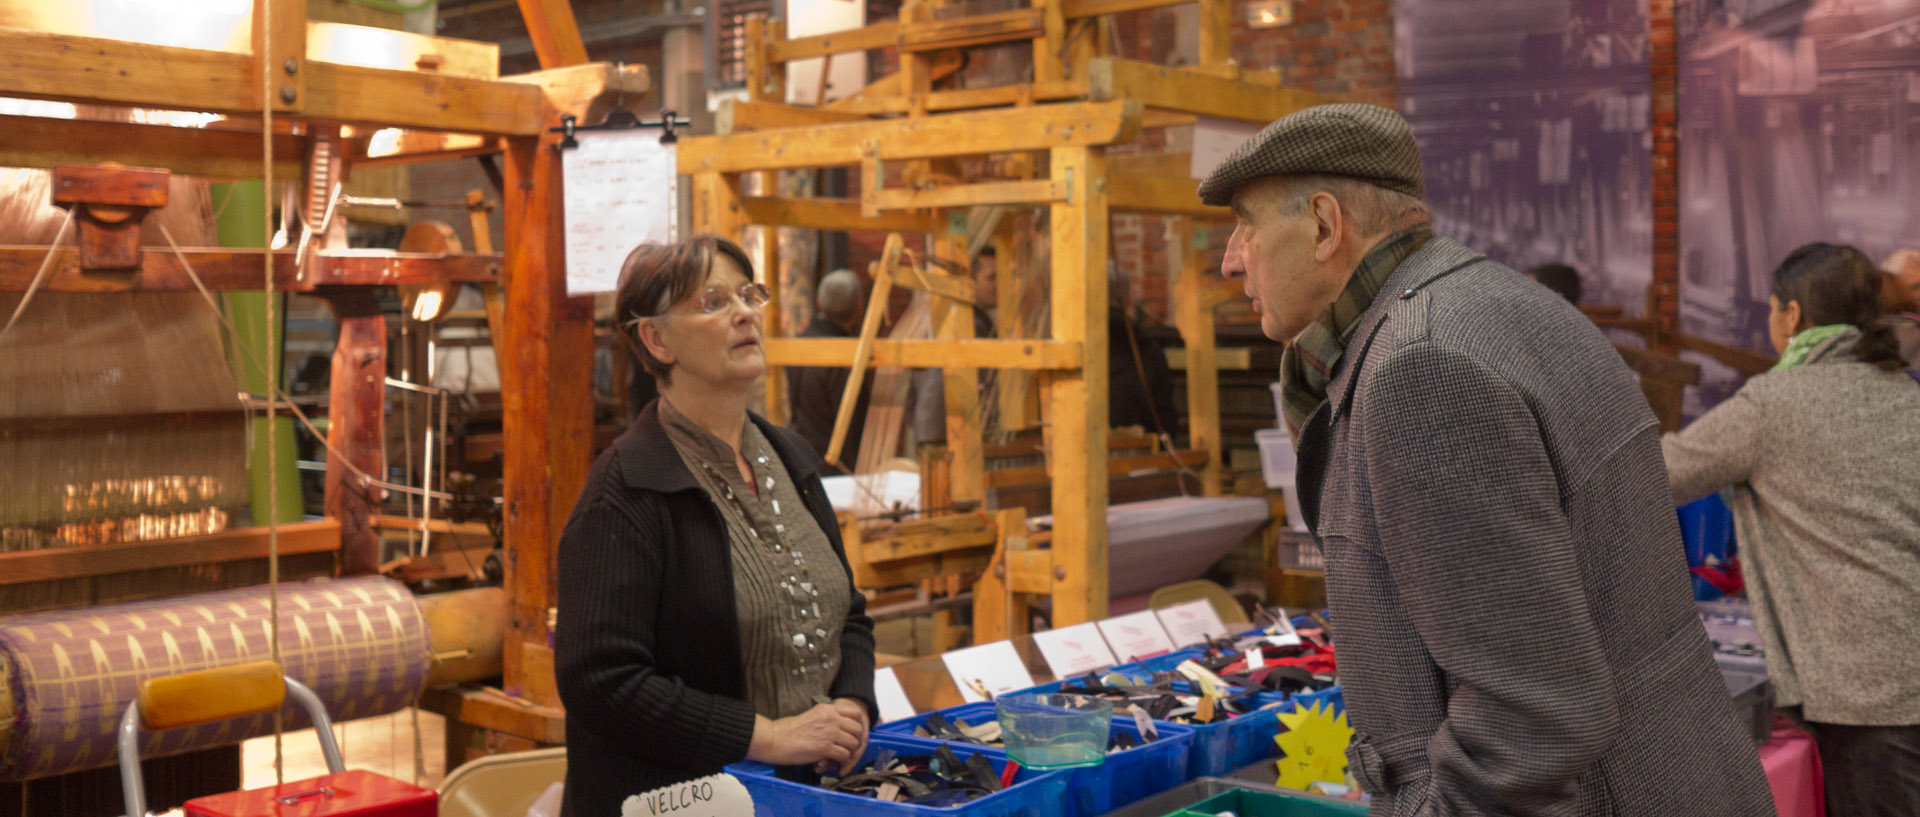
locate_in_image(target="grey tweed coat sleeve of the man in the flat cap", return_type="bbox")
[1354,343,1622,815]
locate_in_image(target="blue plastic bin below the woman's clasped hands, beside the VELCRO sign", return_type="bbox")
[726,731,1069,817]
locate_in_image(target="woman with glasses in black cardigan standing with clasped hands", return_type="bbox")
[555,236,876,817]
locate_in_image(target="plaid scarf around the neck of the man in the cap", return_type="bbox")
[1281,224,1434,447]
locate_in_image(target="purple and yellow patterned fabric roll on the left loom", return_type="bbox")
[0,577,428,781]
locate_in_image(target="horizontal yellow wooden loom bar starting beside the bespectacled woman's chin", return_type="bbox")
[766,338,1081,368]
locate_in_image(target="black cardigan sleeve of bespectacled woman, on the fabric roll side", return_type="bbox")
[555,481,755,769]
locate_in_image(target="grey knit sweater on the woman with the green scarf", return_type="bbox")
[1663,330,1920,725]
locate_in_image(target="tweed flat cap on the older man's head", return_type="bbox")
[1200,102,1427,207]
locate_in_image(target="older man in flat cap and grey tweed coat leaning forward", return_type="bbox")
[1200,104,1774,817]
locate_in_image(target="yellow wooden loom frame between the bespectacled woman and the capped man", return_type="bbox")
[680,0,1334,646]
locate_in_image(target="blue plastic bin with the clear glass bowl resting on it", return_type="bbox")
[874,702,1194,817]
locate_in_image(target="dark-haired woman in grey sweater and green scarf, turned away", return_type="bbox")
[1661,244,1920,817]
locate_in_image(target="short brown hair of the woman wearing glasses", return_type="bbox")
[612,234,753,384]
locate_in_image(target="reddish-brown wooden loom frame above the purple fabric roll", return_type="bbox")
[0,0,649,790]
